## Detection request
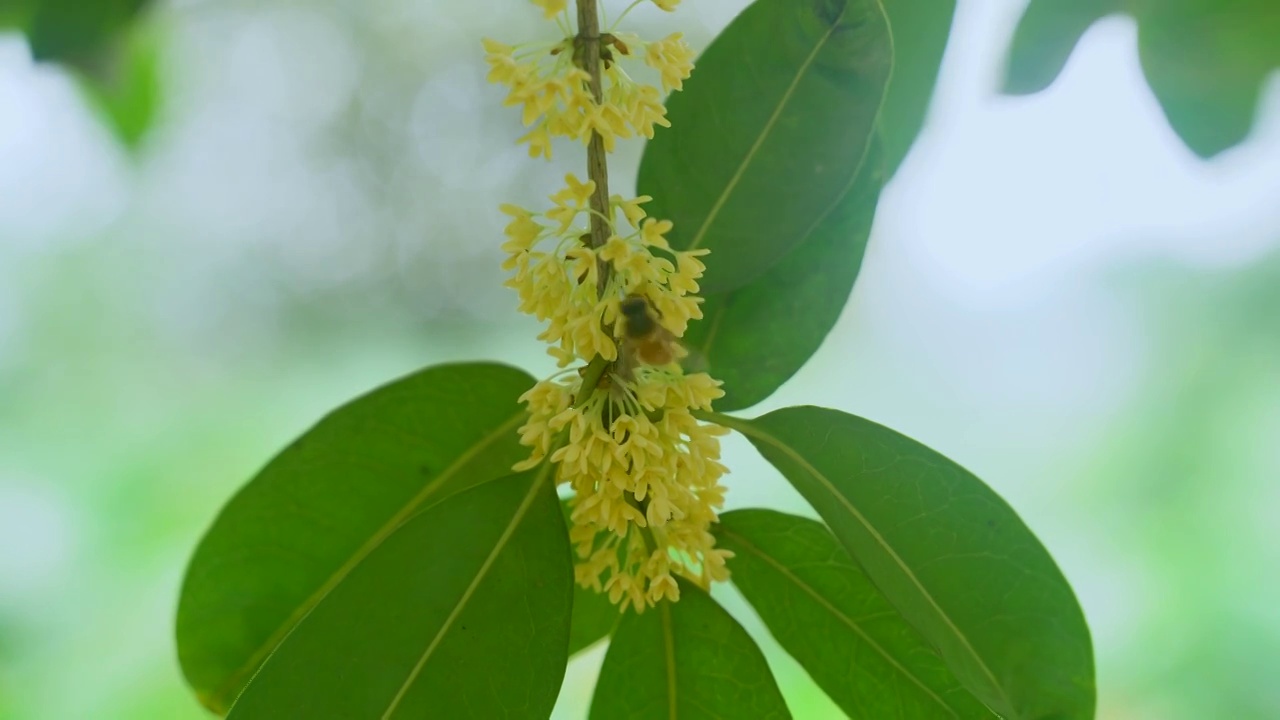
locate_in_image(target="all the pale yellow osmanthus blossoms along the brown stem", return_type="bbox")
[485,0,731,611]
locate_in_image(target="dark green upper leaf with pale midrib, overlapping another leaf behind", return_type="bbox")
[637,0,892,293]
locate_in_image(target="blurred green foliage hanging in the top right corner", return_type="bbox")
[1005,0,1280,158]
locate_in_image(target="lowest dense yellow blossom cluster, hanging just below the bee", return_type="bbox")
[516,358,732,611]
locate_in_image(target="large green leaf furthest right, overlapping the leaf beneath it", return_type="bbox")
[708,407,1094,720]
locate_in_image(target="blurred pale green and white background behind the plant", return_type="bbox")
[0,0,1280,720]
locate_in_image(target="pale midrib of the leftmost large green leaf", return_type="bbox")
[209,411,525,706]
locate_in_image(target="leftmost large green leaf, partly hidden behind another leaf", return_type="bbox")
[177,363,534,714]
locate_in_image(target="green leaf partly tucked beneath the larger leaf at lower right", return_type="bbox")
[716,510,993,720]
